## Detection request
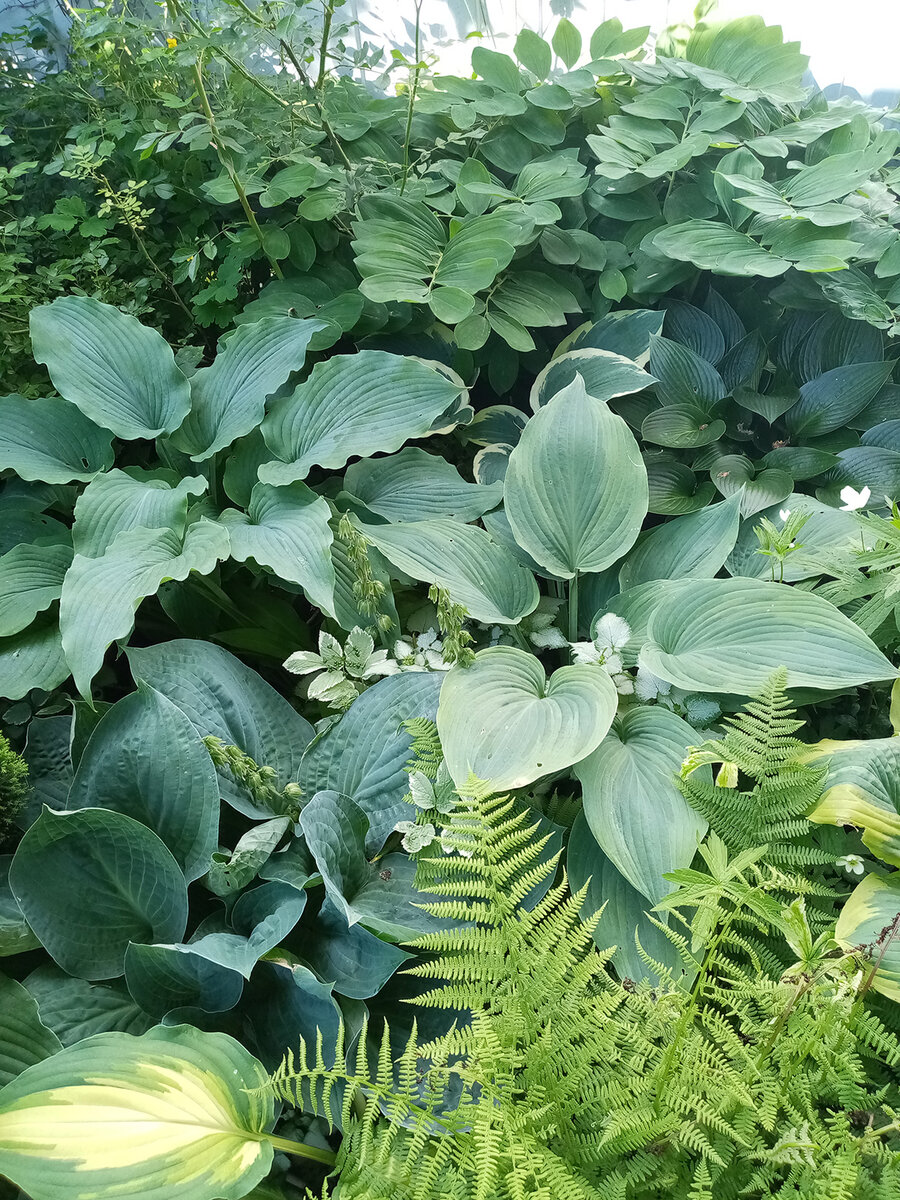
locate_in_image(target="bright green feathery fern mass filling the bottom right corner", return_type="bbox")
[270,763,900,1200]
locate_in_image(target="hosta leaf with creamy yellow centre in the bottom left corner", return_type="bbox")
[0,1025,283,1200]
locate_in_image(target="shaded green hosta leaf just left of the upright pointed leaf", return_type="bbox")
[343,448,504,521]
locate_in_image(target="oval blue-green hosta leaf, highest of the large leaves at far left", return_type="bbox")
[30,296,191,438]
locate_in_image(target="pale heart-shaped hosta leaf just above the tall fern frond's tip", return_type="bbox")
[438,646,618,792]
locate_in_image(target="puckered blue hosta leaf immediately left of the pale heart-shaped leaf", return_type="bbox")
[296,672,444,854]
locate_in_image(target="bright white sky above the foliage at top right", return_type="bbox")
[350,0,900,96]
